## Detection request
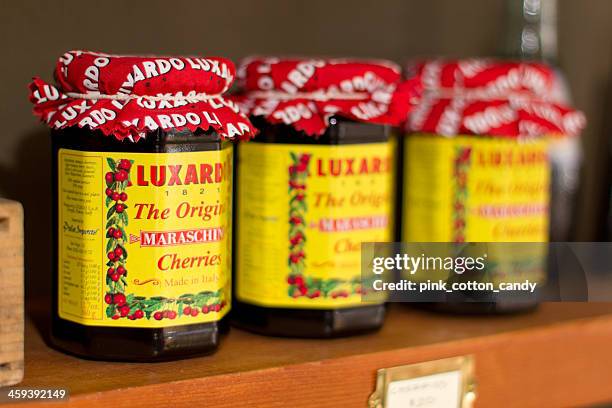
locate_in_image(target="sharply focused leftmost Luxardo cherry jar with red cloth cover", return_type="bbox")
[30,51,254,361]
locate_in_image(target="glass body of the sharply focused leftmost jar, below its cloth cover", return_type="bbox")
[51,128,232,361]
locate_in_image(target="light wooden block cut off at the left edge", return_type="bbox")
[0,199,24,386]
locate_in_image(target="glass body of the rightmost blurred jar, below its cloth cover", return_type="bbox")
[402,134,550,313]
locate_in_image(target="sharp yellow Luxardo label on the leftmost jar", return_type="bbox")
[58,147,232,328]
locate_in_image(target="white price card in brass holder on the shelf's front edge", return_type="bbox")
[369,356,476,408]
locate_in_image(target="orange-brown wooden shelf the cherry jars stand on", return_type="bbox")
[7,303,612,408]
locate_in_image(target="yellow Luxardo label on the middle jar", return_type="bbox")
[236,142,394,308]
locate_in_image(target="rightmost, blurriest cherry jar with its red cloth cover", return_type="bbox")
[402,59,585,313]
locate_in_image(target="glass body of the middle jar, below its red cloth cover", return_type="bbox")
[232,118,395,337]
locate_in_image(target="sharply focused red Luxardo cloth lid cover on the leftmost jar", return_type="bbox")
[29,51,256,141]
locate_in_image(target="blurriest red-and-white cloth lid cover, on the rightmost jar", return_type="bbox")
[406,59,586,138]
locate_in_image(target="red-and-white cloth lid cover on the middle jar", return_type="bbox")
[235,58,420,136]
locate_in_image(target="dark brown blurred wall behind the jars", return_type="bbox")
[0,0,612,297]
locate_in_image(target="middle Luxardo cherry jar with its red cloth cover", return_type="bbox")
[233,58,418,337]
